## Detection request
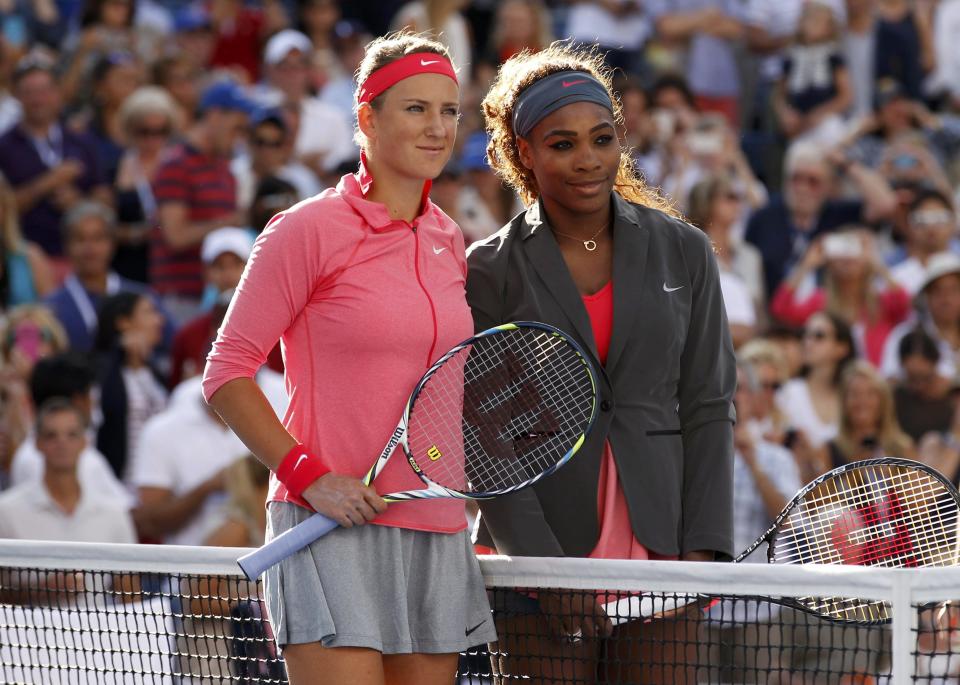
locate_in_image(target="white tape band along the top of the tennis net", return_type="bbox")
[0,540,948,601]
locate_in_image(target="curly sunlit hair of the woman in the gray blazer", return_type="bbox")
[482,41,679,211]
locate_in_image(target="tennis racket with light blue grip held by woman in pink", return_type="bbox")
[238,322,597,580]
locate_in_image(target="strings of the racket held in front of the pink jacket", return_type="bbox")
[408,329,595,492]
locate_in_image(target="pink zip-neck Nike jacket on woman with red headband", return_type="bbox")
[203,169,473,533]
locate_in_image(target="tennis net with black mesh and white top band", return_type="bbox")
[0,541,960,685]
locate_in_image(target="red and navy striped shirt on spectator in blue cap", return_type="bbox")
[150,143,237,298]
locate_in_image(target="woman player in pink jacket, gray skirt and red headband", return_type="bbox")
[204,34,495,685]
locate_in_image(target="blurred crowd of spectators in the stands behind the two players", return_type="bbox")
[0,0,960,568]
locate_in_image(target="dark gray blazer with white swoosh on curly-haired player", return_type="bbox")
[467,193,736,558]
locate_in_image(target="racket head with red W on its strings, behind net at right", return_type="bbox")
[767,458,960,624]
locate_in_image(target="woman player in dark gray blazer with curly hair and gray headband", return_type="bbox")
[467,43,736,683]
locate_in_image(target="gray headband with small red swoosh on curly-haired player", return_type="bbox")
[513,71,613,137]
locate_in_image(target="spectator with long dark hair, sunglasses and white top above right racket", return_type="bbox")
[777,312,854,481]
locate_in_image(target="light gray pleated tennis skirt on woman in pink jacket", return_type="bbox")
[264,502,497,654]
